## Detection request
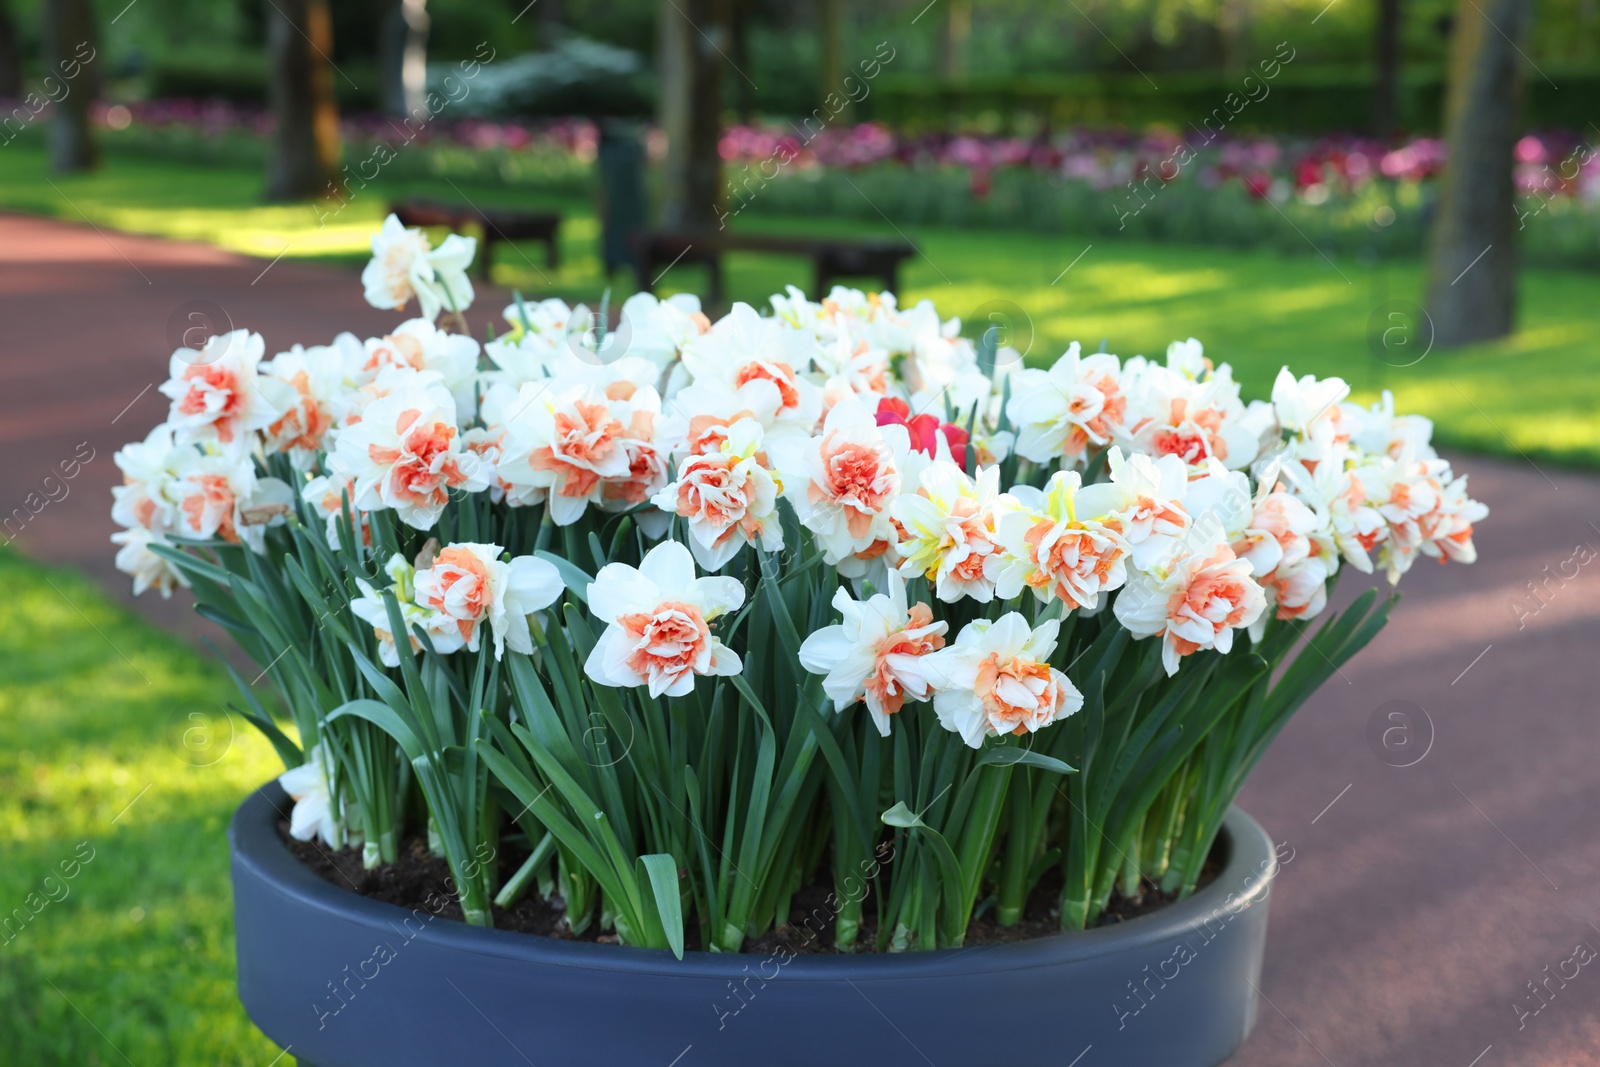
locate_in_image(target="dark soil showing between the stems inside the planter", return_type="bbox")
[278,819,1222,955]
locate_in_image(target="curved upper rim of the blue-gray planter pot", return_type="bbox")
[227,781,1278,982]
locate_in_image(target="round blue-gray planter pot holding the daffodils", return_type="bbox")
[229,784,1277,1067]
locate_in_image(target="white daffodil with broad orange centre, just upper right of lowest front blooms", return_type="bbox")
[1112,531,1267,675]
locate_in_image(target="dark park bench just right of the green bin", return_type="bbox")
[634,230,917,306]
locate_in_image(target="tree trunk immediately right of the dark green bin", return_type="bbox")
[659,0,728,229]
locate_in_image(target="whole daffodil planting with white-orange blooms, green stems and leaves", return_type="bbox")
[112,219,1486,953]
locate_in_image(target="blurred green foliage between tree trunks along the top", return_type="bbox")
[0,0,1600,133]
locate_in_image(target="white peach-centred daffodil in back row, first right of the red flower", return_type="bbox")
[1005,341,1128,464]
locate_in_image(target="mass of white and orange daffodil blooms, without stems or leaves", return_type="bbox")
[115,218,1486,767]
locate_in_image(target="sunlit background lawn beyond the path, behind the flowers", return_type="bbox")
[12,144,1600,466]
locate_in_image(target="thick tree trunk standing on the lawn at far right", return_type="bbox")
[1427,0,1531,346]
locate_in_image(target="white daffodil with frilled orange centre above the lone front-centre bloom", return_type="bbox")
[654,419,784,571]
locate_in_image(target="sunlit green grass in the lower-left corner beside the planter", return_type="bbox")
[0,550,282,1067]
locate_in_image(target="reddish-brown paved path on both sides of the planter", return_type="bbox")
[0,214,1600,1067]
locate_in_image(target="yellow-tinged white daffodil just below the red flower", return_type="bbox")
[890,459,1002,603]
